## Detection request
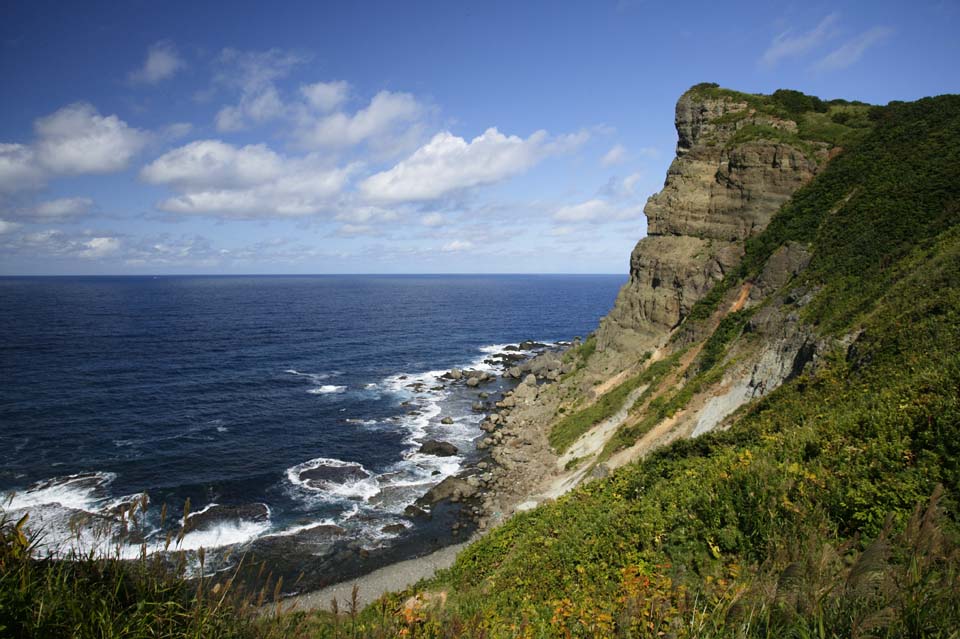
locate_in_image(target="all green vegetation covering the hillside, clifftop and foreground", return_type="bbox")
[0,85,960,637]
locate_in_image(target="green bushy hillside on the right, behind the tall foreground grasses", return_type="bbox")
[402,96,960,636]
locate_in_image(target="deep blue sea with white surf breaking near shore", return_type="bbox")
[0,275,625,576]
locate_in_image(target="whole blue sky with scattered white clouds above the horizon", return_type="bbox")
[0,0,960,275]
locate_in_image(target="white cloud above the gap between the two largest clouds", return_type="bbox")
[297,91,424,148]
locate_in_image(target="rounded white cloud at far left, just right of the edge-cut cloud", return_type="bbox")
[34,102,148,174]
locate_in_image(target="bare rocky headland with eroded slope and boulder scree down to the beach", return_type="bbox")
[294,85,892,608]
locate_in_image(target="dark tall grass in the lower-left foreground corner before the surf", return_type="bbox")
[0,504,291,639]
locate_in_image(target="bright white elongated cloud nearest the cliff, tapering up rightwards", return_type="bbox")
[360,128,588,202]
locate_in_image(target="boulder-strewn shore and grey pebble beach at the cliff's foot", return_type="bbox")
[278,337,580,608]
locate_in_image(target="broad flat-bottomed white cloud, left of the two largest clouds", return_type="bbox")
[140,140,358,218]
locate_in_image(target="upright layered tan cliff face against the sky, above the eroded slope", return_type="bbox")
[597,87,827,353]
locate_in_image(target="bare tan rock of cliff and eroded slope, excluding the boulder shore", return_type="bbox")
[462,81,852,524]
